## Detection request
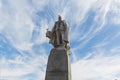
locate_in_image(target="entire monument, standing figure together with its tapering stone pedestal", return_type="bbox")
[45,16,71,80]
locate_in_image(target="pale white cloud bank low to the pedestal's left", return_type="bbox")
[0,54,47,80]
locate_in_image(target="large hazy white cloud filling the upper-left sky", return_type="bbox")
[0,0,47,50]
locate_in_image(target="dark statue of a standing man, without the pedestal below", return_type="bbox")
[46,16,69,48]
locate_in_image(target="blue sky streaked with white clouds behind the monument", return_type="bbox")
[0,0,120,80]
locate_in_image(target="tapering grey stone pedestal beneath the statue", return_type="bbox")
[45,47,71,80]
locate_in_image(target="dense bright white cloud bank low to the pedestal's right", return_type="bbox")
[72,48,120,80]
